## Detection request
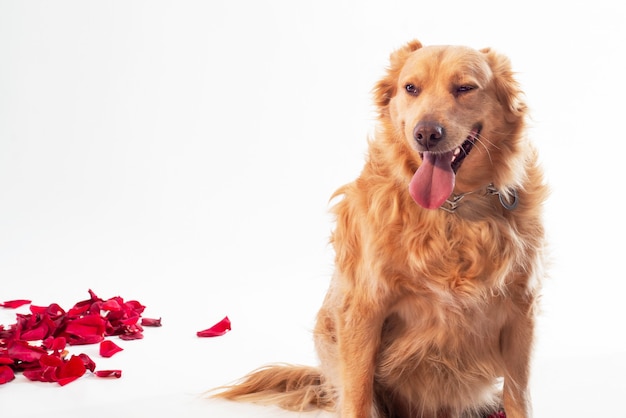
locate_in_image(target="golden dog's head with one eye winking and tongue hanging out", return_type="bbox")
[375,41,526,209]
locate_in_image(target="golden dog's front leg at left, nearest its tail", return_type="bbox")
[337,290,384,418]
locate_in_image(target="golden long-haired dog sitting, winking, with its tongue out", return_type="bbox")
[213,40,548,418]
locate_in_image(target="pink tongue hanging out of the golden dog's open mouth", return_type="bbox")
[409,151,454,209]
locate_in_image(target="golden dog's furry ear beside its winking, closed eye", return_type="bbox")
[480,48,526,122]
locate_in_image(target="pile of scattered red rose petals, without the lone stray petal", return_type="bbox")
[0,290,161,386]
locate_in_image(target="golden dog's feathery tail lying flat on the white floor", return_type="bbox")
[210,364,336,411]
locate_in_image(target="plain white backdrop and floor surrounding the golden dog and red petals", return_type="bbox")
[0,0,626,418]
